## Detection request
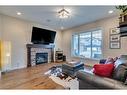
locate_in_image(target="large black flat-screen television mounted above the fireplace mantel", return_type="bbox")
[31,27,56,44]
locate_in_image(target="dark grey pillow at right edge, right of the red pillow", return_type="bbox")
[113,64,127,82]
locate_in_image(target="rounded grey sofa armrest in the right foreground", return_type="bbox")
[77,70,127,89]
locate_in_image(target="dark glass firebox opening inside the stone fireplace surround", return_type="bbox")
[36,53,48,65]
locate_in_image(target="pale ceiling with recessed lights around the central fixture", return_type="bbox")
[0,6,118,30]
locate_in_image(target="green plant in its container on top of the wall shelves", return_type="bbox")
[116,5,127,23]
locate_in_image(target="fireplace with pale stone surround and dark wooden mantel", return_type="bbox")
[26,44,54,67]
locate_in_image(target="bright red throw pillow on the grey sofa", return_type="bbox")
[93,64,114,77]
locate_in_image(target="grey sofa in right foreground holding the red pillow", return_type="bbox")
[76,55,127,89]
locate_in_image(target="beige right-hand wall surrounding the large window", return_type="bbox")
[62,16,127,64]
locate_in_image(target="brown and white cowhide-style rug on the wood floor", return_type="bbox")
[45,65,79,90]
